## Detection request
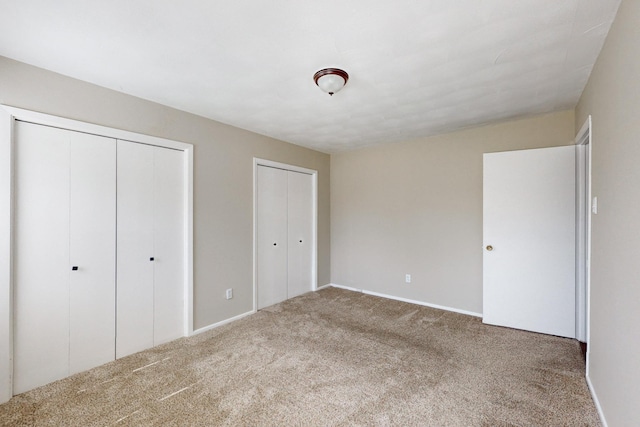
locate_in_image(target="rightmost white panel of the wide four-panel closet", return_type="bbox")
[153,147,185,345]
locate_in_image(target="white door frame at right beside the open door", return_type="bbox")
[575,116,592,354]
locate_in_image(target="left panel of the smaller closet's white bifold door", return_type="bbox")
[257,166,287,309]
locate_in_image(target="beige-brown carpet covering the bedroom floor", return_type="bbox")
[0,288,600,426]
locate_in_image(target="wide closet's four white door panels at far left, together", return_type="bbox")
[12,115,190,394]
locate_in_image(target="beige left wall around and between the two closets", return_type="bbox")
[0,57,330,329]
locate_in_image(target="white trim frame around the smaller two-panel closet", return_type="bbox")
[252,157,318,313]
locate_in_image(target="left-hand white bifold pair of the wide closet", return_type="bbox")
[13,122,116,394]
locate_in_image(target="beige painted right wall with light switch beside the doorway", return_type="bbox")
[576,0,640,426]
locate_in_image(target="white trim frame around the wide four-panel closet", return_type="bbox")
[0,105,194,403]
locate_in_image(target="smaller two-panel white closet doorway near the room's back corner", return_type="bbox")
[255,161,316,309]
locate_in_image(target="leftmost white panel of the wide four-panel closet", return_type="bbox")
[13,122,71,394]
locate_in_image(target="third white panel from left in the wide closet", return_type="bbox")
[116,141,154,357]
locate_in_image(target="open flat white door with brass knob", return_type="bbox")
[483,146,575,338]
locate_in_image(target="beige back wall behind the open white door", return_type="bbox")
[331,111,574,313]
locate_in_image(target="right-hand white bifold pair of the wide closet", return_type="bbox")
[116,141,185,357]
